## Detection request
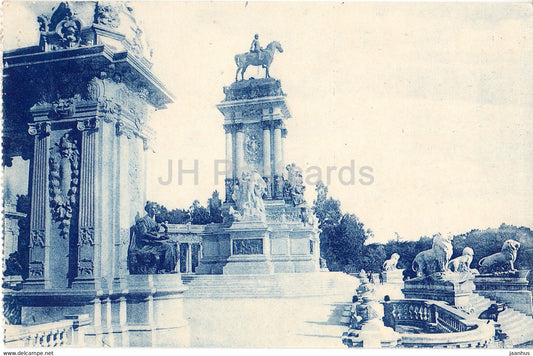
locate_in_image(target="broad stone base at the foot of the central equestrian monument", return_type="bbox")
[196,200,320,274]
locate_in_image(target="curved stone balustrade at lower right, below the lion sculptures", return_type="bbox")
[383,299,494,347]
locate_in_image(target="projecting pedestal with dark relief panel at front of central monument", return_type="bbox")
[223,219,274,274]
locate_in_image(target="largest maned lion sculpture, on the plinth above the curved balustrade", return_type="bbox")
[411,234,453,277]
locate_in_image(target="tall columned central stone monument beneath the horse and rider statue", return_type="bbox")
[197,41,320,274]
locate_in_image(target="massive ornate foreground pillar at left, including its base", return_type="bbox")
[3,2,190,346]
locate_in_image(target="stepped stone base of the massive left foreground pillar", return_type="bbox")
[10,274,190,347]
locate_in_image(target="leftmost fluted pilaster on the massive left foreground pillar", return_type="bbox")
[27,123,51,288]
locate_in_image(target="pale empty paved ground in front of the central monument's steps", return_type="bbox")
[184,295,351,348]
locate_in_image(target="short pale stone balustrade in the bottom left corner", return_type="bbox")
[4,315,90,347]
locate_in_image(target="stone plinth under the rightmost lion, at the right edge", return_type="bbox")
[474,270,533,315]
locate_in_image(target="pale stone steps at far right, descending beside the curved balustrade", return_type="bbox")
[471,293,533,346]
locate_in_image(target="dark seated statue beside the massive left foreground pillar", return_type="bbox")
[128,202,178,274]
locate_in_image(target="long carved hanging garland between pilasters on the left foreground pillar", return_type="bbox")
[49,133,80,238]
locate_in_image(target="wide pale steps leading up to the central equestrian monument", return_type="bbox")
[182,272,358,298]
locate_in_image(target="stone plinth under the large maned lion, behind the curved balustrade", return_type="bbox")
[402,274,474,311]
